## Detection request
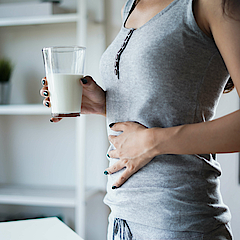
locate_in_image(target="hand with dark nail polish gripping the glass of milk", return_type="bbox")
[40,76,106,122]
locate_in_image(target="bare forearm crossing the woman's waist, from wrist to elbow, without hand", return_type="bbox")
[151,110,240,155]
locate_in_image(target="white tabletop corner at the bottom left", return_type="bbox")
[0,217,83,240]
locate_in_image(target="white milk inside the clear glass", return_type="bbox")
[47,73,83,114]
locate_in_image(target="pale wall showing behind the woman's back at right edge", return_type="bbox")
[215,90,240,240]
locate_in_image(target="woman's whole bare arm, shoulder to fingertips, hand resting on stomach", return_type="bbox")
[106,0,240,187]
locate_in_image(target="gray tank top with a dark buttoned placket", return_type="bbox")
[100,0,230,232]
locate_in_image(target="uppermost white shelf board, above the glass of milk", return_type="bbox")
[0,13,79,27]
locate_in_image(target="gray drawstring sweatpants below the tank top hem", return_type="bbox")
[108,214,233,240]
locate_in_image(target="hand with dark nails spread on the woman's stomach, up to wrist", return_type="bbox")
[105,122,154,189]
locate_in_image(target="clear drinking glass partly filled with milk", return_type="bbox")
[42,46,86,118]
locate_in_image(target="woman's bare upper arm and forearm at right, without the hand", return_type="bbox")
[153,0,240,154]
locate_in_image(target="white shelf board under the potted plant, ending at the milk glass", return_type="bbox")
[0,104,51,116]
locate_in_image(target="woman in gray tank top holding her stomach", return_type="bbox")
[41,0,240,240]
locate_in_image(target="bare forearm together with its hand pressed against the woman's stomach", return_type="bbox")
[106,108,240,188]
